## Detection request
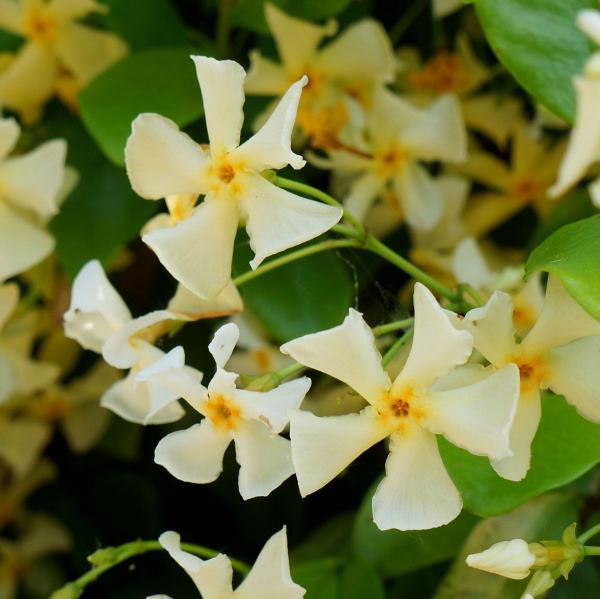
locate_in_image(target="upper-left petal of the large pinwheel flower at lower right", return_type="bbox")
[281,308,390,401]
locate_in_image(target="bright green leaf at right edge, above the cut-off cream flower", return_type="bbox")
[525,215,600,320]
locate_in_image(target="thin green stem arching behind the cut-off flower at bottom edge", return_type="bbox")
[50,541,250,599]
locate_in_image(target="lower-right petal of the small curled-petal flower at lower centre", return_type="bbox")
[233,420,294,499]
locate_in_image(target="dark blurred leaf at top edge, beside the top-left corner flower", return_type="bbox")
[104,0,186,51]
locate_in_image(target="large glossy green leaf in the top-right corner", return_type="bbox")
[475,0,598,123]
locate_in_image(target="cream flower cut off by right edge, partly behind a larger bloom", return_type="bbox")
[450,275,600,480]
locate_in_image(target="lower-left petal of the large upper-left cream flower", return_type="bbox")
[142,198,238,299]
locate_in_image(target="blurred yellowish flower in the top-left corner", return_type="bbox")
[0,0,127,122]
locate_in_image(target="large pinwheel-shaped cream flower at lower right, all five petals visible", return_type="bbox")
[281,283,518,530]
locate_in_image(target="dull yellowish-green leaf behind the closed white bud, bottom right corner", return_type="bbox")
[433,493,578,599]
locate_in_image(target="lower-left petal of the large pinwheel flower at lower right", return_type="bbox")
[290,406,389,497]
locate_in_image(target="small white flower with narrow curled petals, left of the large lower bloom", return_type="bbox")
[136,323,310,499]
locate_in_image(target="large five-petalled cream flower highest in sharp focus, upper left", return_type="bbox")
[125,56,342,299]
